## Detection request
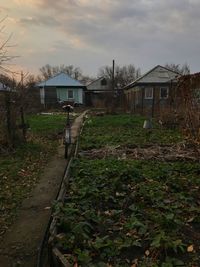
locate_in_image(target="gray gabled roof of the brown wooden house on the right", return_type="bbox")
[125,65,181,88]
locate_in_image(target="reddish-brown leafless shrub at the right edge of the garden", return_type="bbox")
[159,73,200,143]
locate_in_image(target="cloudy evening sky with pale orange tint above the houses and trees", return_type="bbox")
[0,0,200,79]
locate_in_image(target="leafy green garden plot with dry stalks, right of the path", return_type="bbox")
[54,115,200,267]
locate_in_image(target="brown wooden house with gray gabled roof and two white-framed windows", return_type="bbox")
[124,65,181,117]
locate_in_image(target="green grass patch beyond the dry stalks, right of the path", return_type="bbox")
[81,114,183,150]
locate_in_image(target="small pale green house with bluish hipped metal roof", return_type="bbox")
[37,72,86,107]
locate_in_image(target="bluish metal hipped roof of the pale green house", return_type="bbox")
[37,72,85,87]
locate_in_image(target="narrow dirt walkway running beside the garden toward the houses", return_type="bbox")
[0,112,86,267]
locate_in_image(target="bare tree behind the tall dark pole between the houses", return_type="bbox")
[98,64,141,88]
